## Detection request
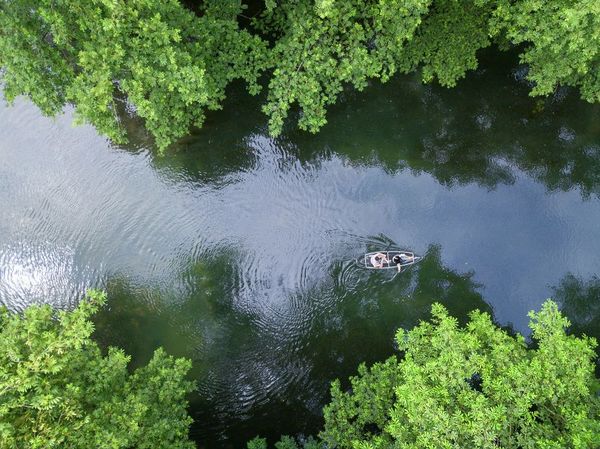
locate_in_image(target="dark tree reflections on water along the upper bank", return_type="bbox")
[139,50,600,196]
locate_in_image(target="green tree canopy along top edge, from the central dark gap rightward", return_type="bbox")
[261,0,600,134]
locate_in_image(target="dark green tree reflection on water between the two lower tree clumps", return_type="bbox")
[95,246,491,447]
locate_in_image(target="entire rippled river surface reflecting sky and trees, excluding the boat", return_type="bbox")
[0,53,600,448]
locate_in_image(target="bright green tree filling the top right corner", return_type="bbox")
[488,0,600,102]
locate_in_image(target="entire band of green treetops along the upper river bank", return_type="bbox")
[0,0,600,149]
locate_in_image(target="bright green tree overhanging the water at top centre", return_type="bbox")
[261,0,431,134]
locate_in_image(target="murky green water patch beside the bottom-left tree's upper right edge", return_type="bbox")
[94,252,244,377]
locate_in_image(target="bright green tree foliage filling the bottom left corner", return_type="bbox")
[0,292,194,449]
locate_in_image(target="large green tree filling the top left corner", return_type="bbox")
[0,0,266,148]
